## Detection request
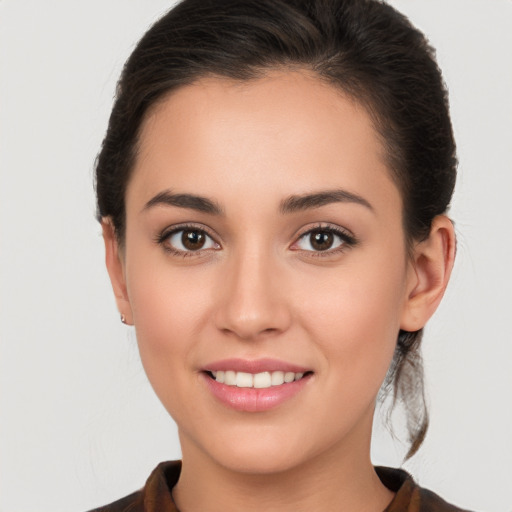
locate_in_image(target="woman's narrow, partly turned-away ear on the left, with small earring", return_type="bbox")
[101,218,133,325]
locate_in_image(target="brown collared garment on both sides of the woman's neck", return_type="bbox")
[90,461,467,512]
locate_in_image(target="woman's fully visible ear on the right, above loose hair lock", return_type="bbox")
[400,215,456,332]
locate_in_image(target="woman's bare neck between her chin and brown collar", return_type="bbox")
[173,410,393,512]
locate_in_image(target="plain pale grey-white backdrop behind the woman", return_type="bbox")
[0,0,512,512]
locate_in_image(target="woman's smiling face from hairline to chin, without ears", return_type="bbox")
[115,72,414,472]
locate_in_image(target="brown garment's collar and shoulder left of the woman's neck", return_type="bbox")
[84,461,181,512]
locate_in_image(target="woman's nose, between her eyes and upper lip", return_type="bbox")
[216,249,292,340]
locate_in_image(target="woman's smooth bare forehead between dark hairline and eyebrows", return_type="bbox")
[127,71,399,212]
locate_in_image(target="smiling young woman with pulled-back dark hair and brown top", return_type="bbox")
[89,0,468,512]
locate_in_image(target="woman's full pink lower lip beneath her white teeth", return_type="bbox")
[203,373,311,412]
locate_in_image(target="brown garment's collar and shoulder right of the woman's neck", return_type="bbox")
[375,467,476,512]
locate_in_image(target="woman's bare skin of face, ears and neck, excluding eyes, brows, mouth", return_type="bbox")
[103,71,454,512]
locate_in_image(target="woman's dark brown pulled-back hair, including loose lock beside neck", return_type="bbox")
[96,0,456,457]
